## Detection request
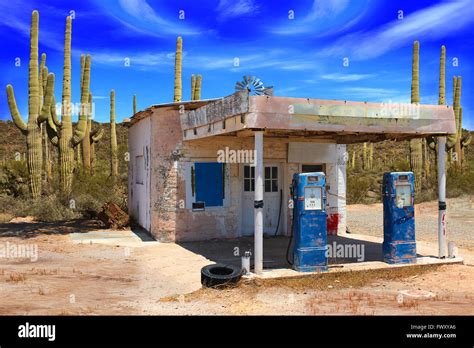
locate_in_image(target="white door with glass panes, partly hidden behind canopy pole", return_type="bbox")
[242,164,282,236]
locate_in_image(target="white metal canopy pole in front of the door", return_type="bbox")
[254,131,263,274]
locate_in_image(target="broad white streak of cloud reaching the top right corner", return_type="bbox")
[321,0,474,60]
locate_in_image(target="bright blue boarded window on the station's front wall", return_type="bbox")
[194,162,225,207]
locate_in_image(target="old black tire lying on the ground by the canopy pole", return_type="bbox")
[201,263,242,288]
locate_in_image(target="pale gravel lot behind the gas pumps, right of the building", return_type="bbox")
[347,195,474,250]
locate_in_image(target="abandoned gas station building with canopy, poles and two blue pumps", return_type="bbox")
[128,91,462,274]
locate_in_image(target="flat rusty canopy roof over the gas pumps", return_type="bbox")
[180,91,456,143]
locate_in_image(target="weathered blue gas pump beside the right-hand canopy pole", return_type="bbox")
[382,172,416,263]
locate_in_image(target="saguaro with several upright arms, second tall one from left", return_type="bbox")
[43,16,91,195]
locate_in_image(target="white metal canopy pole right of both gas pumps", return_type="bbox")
[438,137,446,259]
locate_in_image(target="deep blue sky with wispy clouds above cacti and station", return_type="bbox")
[0,0,474,129]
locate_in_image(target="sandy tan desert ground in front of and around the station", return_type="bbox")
[0,196,474,315]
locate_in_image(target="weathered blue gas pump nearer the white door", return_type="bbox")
[291,172,328,272]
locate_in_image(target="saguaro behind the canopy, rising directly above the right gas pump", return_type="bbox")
[410,41,423,192]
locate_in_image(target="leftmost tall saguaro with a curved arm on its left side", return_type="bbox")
[7,11,46,198]
